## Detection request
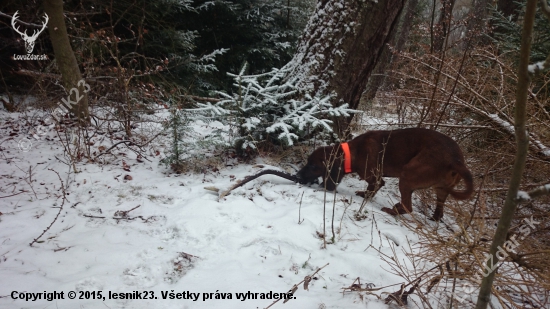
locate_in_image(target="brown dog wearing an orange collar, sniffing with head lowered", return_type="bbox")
[296,128,473,221]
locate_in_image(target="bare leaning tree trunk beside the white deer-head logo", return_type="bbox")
[44,0,90,123]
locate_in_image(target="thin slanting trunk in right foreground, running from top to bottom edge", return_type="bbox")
[476,0,537,309]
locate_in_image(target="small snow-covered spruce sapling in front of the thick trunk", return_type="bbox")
[196,64,356,154]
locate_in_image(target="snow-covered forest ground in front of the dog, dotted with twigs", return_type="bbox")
[0,113,426,309]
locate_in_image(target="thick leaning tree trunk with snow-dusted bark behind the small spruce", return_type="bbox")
[285,0,406,136]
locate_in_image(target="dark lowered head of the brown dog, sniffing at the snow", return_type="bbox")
[296,146,343,191]
